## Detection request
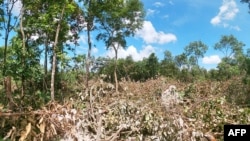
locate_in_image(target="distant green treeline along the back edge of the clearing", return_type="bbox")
[98,35,250,83]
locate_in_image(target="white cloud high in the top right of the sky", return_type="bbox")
[210,0,240,30]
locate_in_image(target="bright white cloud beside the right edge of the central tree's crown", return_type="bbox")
[136,21,177,44]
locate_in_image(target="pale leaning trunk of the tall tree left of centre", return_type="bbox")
[50,4,65,101]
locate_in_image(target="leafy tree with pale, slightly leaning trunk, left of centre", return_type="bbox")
[19,0,83,101]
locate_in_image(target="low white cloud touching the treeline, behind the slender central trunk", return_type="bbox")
[107,45,155,61]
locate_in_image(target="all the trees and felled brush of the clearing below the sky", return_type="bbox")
[0,0,250,141]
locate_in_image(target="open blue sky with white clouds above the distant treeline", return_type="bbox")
[83,0,250,69]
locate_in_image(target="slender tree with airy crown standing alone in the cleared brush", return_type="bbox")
[97,0,144,93]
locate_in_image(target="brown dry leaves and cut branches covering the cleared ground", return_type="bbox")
[0,77,250,141]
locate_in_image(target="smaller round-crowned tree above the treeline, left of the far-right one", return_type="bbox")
[185,41,208,65]
